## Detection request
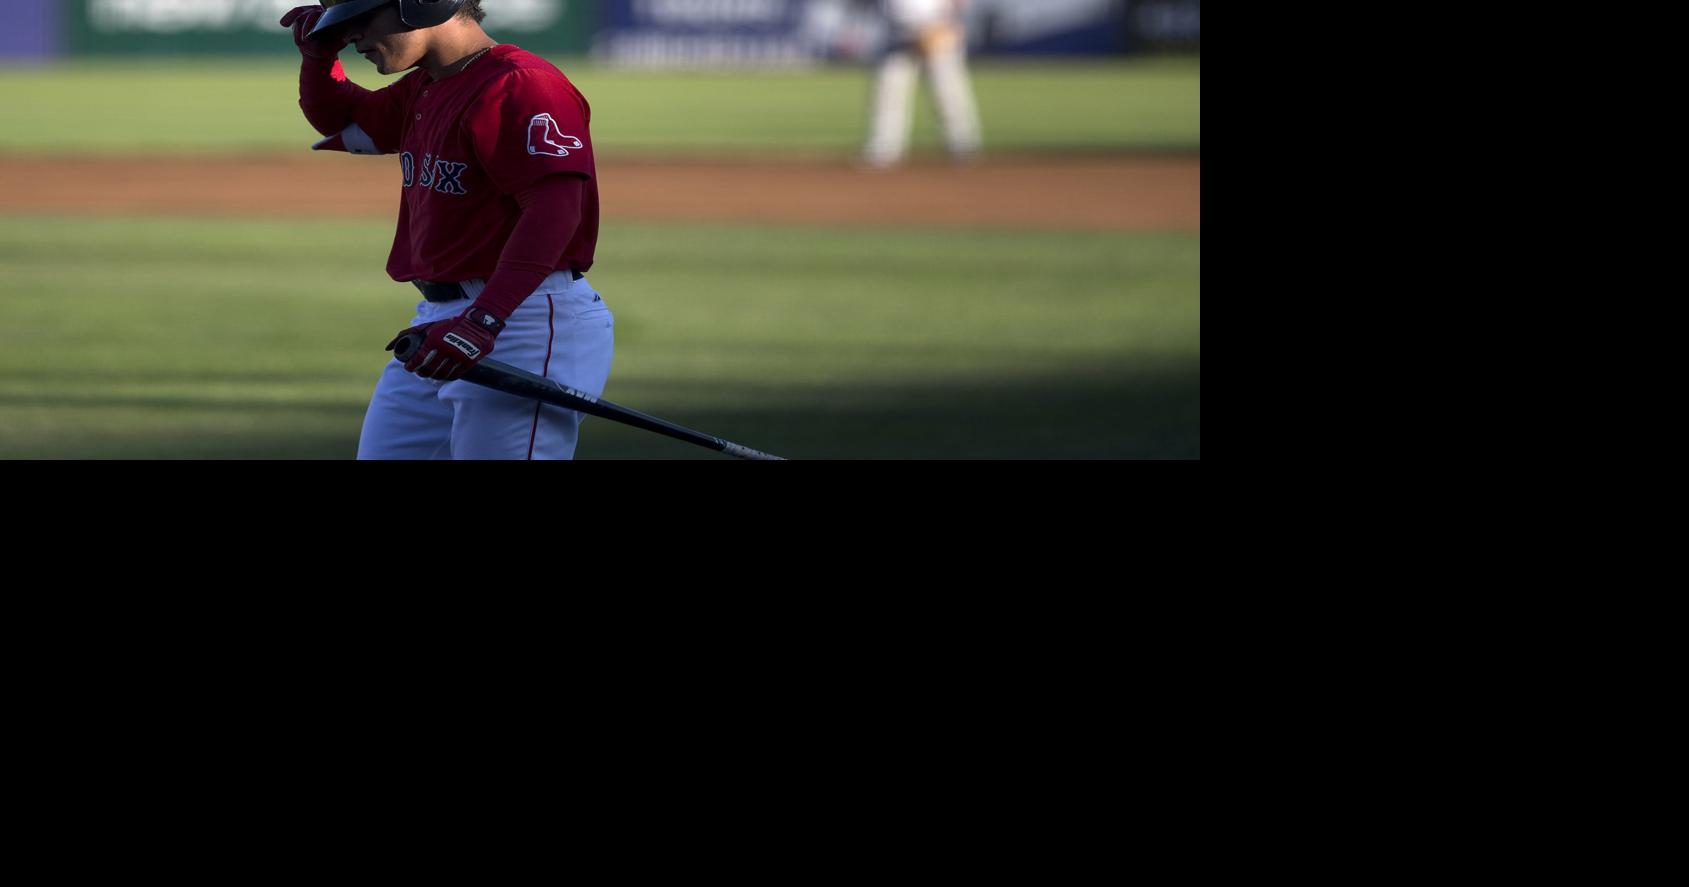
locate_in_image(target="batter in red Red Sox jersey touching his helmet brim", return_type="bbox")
[282,0,615,460]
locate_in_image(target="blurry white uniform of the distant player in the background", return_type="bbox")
[863,0,980,167]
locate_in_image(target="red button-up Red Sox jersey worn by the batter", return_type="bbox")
[353,44,598,280]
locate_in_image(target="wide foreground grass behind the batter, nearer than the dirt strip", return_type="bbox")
[0,218,1201,458]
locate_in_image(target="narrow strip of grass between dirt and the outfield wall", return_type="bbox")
[0,59,1201,155]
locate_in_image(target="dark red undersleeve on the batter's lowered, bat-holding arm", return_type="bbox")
[475,176,586,319]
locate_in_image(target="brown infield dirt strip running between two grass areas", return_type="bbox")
[0,154,1201,231]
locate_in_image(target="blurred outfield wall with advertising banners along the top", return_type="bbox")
[0,0,1201,61]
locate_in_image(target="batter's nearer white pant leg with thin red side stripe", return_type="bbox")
[439,272,615,460]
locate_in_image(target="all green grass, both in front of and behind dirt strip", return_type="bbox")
[0,59,1201,460]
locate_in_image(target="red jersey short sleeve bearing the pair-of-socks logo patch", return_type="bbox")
[464,69,593,194]
